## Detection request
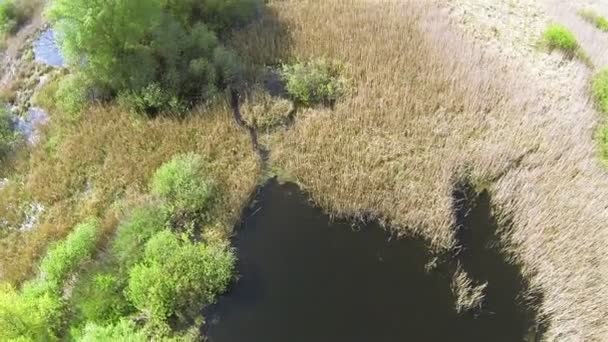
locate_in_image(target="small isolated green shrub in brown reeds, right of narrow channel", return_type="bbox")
[282,60,346,106]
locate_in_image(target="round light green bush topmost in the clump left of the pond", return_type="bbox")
[151,153,215,211]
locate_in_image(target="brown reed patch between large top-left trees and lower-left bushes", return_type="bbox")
[0,105,260,283]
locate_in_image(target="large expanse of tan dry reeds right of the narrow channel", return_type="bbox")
[234,0,608,341]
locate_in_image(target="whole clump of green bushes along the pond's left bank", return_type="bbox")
[70,153,235,341]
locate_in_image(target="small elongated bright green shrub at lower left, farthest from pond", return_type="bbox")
[40,220,99,288]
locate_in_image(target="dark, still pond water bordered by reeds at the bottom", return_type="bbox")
[204,181,531,342]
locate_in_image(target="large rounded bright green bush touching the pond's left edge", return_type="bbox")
[127,231,235,322]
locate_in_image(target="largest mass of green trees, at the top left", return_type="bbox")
[49,0,261,114]
